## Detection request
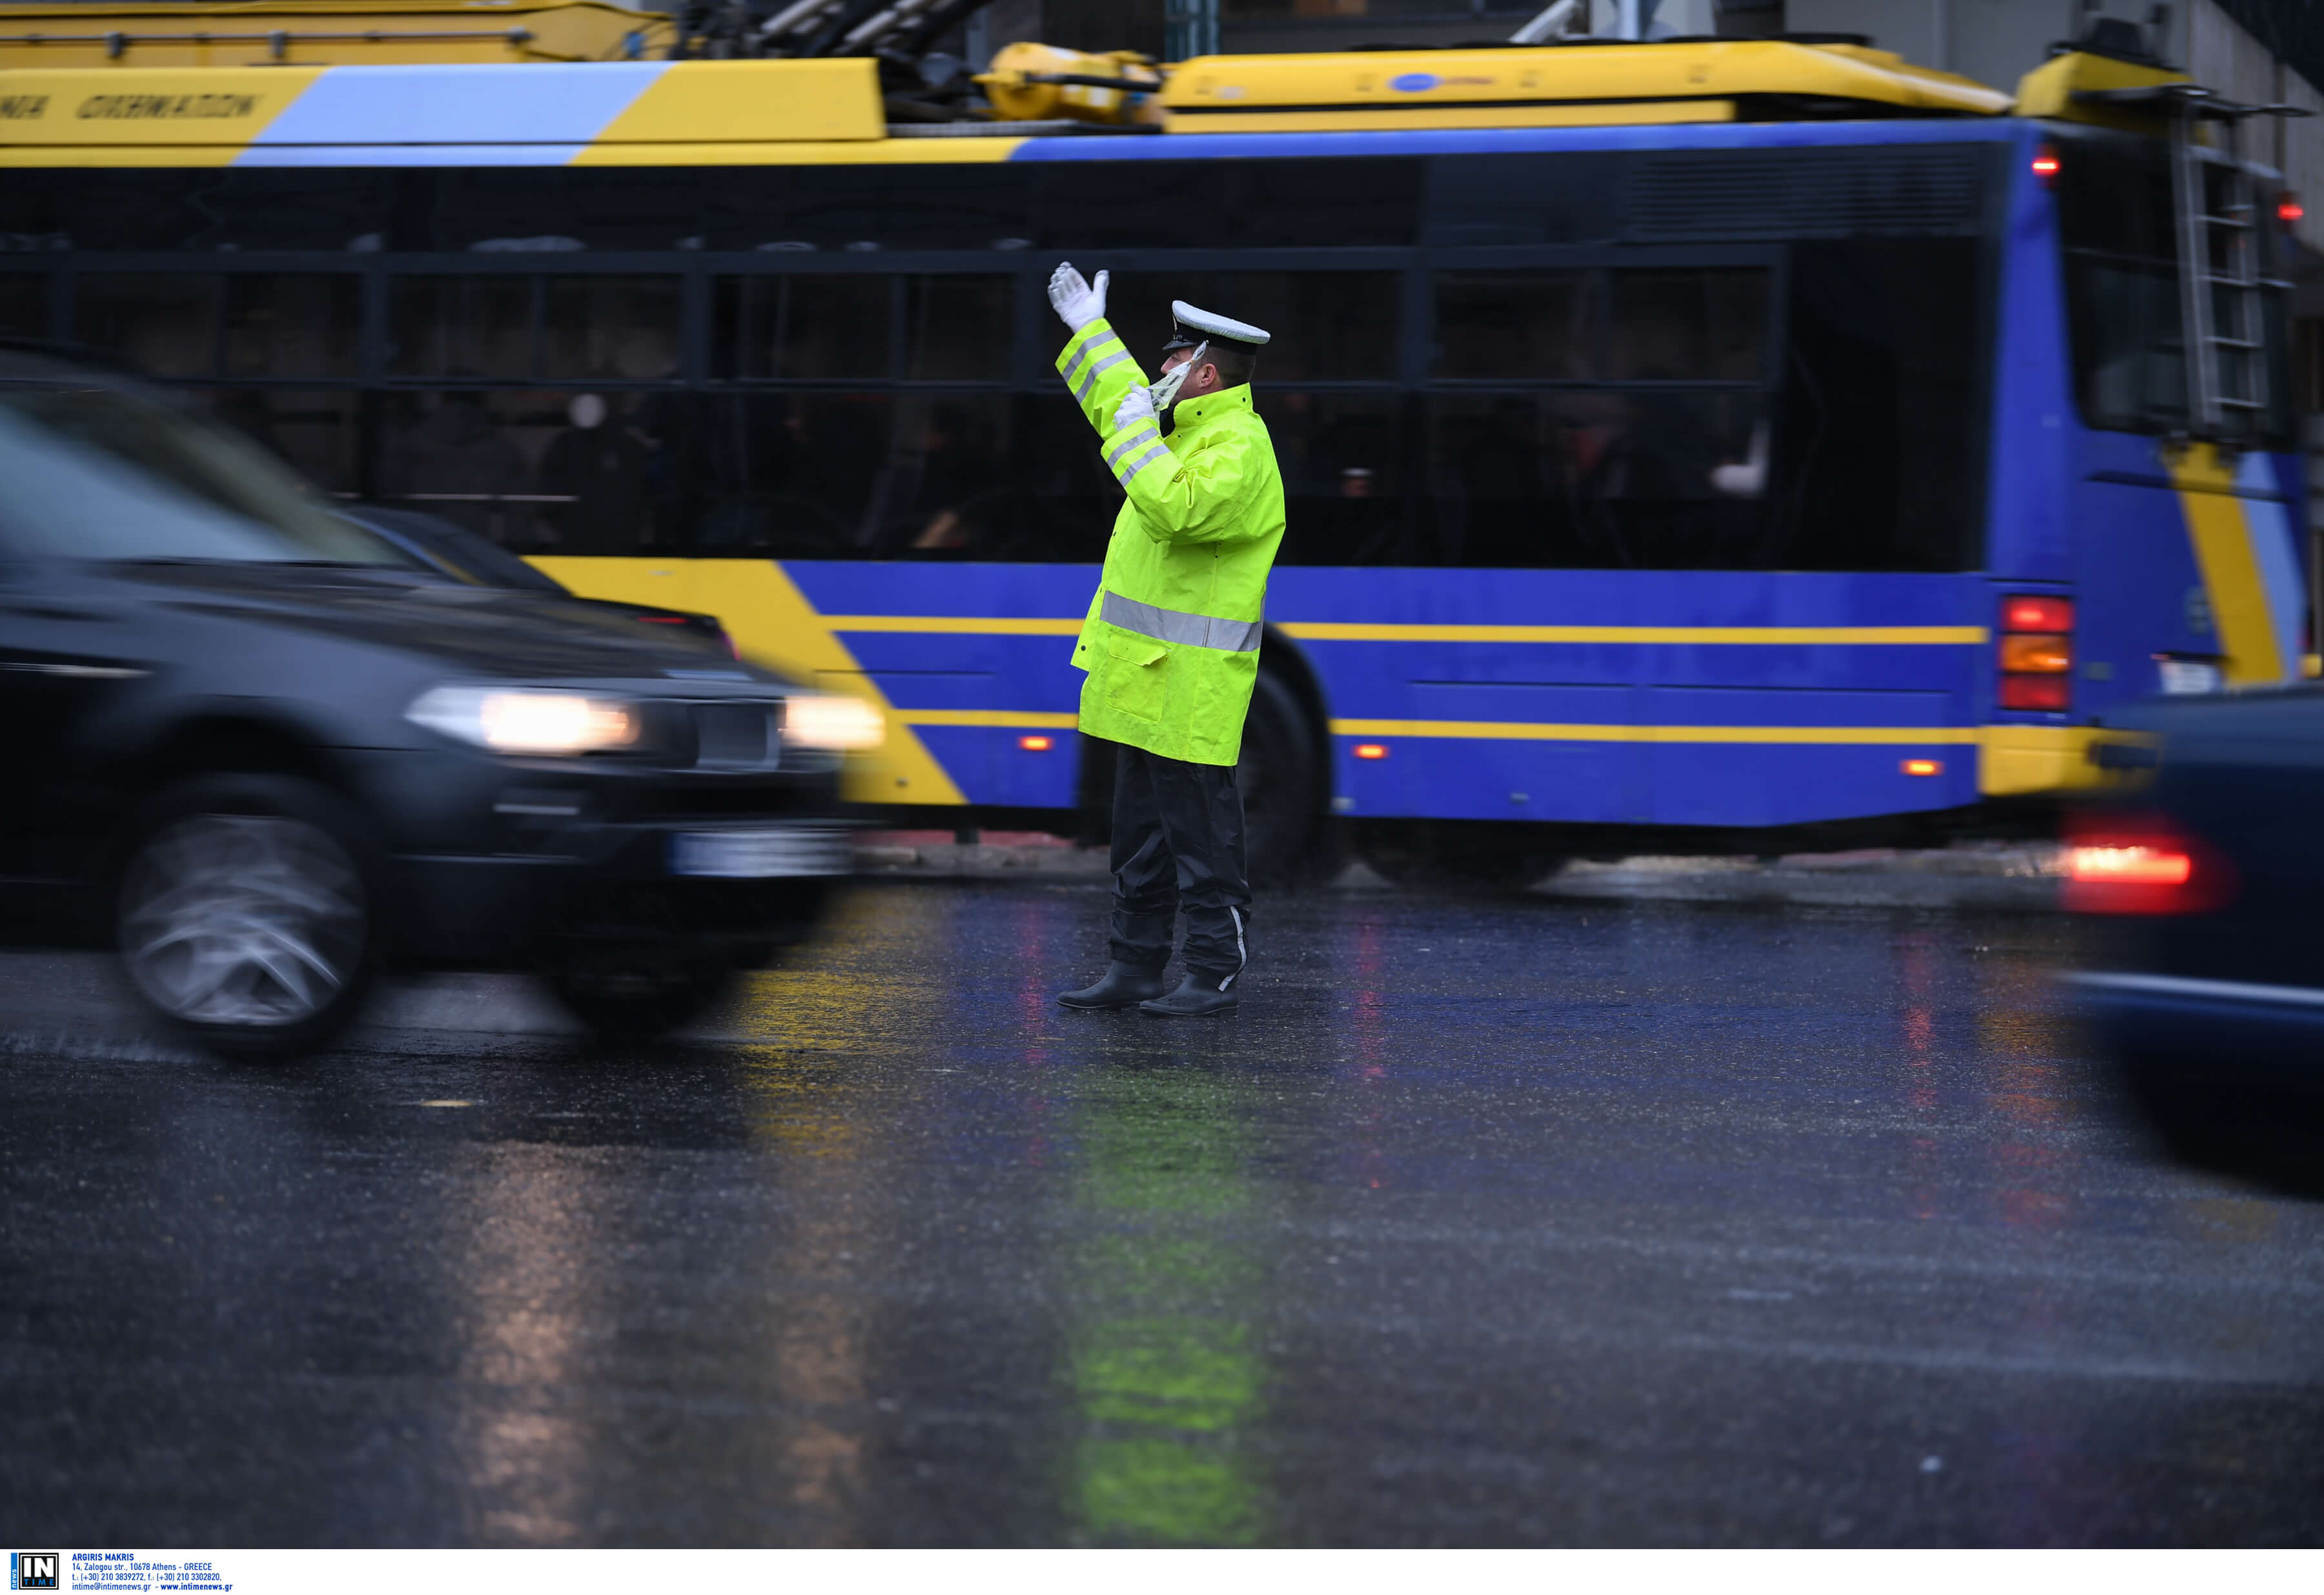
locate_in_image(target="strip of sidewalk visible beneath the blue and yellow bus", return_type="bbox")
[855,830,2061,914]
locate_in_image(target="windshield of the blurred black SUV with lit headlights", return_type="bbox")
[0,389,414,570]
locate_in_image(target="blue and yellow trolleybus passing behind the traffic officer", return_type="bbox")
[0,15,2308,872]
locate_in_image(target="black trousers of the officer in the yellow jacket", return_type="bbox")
[1108,746,1250,988]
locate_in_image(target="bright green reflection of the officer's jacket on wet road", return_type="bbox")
[1069,1070,1269,1546]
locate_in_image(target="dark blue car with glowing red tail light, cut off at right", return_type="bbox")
[2066,688,2324,1172]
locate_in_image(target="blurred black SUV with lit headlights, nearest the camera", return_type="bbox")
[0,351,879,1053]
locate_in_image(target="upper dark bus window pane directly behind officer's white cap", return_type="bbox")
[1106,272,1402,389]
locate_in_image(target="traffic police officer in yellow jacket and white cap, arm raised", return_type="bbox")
[1048,265,1283,1019]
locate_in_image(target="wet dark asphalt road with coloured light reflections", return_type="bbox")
[0,884,2324,1546]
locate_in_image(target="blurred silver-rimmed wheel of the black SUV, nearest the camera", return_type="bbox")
[114,774,379,1058]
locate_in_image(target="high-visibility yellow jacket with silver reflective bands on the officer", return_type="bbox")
[1057,321,1283,765]
